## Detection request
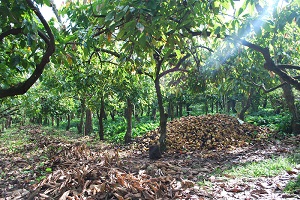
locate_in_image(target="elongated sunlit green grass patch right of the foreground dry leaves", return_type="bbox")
[222,154,300,177]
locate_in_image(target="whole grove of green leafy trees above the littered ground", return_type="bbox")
[0,0,300,151]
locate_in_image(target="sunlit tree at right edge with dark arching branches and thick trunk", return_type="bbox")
[232,1,300,134]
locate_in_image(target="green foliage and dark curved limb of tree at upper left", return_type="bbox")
[0,0,55,98]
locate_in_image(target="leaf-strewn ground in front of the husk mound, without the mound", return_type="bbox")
[0,115,300,200]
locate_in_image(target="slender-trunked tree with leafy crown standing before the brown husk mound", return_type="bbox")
[85,0,228,151]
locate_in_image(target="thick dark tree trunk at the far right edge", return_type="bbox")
[281,80,300,134]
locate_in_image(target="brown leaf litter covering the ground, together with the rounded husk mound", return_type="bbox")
[0,114,300,200]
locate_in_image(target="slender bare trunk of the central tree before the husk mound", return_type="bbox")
[154,78,167,152]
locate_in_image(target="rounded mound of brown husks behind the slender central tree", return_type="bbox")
[135,114,270,153]
